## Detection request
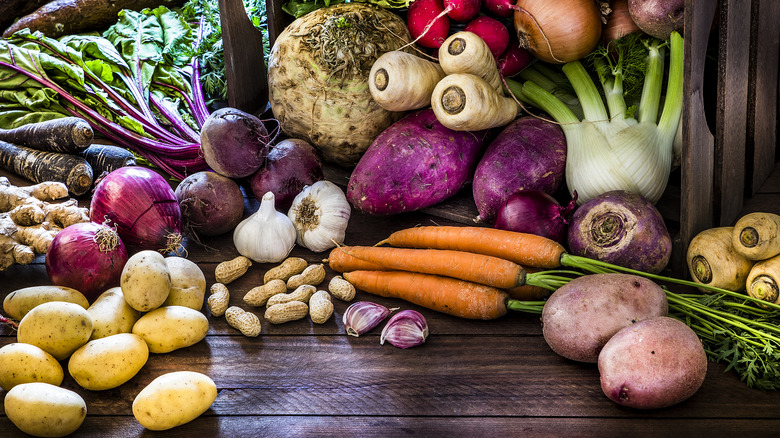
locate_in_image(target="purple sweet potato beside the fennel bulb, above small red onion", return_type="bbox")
[472,116,566,222]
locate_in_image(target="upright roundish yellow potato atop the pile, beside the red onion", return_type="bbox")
[119,250,171,312]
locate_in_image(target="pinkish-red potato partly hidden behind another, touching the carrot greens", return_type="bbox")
[542,274,669,363]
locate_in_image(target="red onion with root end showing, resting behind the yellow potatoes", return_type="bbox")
[46,222,128,303]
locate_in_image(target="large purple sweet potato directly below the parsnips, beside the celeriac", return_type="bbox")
[347,108,487,215]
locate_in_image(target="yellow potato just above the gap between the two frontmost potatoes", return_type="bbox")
[68,333,149,391]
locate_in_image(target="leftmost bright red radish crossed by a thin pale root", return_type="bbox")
[406,0,450,49]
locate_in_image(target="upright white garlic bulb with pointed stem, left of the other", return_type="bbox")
[233,192,295,263]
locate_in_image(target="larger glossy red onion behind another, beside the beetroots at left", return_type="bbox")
[89,166,182,253]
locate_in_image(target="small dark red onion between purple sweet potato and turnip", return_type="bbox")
[493,189,577,244]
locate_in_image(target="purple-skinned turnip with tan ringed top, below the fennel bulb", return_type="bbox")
[568,190,672,274]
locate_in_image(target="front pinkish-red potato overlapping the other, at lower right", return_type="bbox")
[598,316,707,409]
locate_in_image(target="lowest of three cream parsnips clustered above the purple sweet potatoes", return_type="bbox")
[431,73,520,131]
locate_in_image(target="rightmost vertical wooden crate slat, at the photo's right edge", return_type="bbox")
[746,0,780,195]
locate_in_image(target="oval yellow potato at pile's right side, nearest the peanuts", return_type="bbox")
[133,306,209,353]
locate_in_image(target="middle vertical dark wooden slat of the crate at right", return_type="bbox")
[714,0,752,224]
